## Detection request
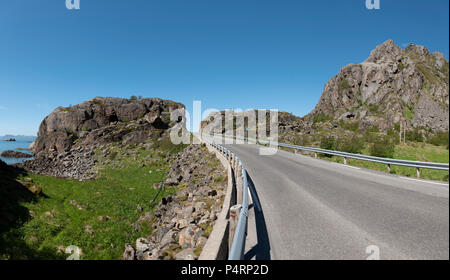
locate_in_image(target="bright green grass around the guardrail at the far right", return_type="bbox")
[322,144,449,181]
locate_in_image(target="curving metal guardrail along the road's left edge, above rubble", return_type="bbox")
[210,142,248,260]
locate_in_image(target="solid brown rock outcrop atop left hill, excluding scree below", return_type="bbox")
[32,97,184,154]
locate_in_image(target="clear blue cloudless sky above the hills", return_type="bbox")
[0,0,449,135]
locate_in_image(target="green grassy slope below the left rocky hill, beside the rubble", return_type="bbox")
[0,139,183,259]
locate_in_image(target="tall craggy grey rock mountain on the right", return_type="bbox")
[305,40,449,131]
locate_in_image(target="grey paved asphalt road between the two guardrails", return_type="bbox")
[226,145,449,259]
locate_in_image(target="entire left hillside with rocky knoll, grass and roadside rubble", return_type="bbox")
[0,97,228,260]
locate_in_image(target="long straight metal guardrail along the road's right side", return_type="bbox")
[215,134,449,177]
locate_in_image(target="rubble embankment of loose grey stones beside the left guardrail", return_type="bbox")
[123,145,227,260]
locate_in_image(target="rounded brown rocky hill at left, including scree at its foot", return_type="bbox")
[24,97,184,179]
